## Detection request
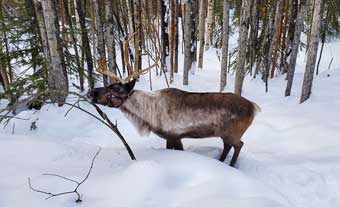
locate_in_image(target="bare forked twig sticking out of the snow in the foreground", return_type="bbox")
[28,148,101,203]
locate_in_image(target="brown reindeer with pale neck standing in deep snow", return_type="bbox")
[88,58,260,166]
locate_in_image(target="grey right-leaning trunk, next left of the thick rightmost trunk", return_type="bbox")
[285,0,307,96]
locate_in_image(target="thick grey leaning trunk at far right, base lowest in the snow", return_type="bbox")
[300,0,322,103]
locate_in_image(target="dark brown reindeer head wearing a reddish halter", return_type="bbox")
[87,79,136,108]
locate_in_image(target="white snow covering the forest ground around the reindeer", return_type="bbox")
[0,39,340,207]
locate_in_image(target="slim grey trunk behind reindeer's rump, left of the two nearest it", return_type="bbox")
[219,0,230,91]
